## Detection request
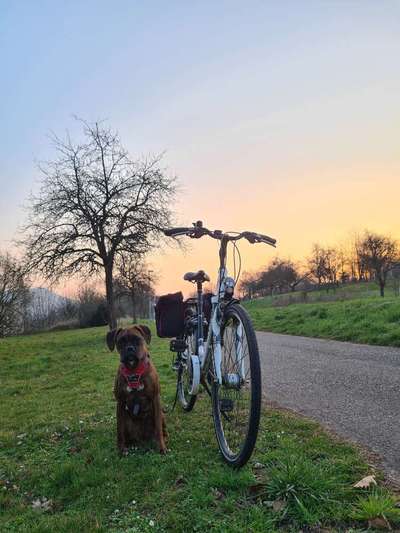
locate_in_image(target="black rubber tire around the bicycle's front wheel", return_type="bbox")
[211,303,261,468]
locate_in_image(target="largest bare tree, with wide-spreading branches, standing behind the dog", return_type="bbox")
[21,122,176,328]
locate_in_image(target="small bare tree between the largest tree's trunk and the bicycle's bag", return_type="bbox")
[116,254,157,322]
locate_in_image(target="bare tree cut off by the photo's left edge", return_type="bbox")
[0,254,29,337]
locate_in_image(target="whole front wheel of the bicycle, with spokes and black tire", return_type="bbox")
[211,304,261,468]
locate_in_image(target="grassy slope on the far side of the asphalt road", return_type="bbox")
[244,283,400,346]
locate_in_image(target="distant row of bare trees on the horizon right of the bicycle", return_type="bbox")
[240,231,400,299]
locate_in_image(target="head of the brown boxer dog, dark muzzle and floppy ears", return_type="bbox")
[106,325,151,368]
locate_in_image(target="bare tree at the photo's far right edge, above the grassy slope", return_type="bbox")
[359,231,399,297]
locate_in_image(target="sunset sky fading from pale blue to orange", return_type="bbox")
[0,0,400,293]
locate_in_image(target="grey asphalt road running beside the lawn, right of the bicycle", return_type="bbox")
[257,332,400,480]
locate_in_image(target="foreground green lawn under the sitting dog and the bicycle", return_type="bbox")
[0,328,400,533]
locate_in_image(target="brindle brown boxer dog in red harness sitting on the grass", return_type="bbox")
[106,325,167,455]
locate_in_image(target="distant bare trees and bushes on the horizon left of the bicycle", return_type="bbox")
[0,252,156,338]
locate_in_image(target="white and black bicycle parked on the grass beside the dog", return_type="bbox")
[164,221,276,468]
